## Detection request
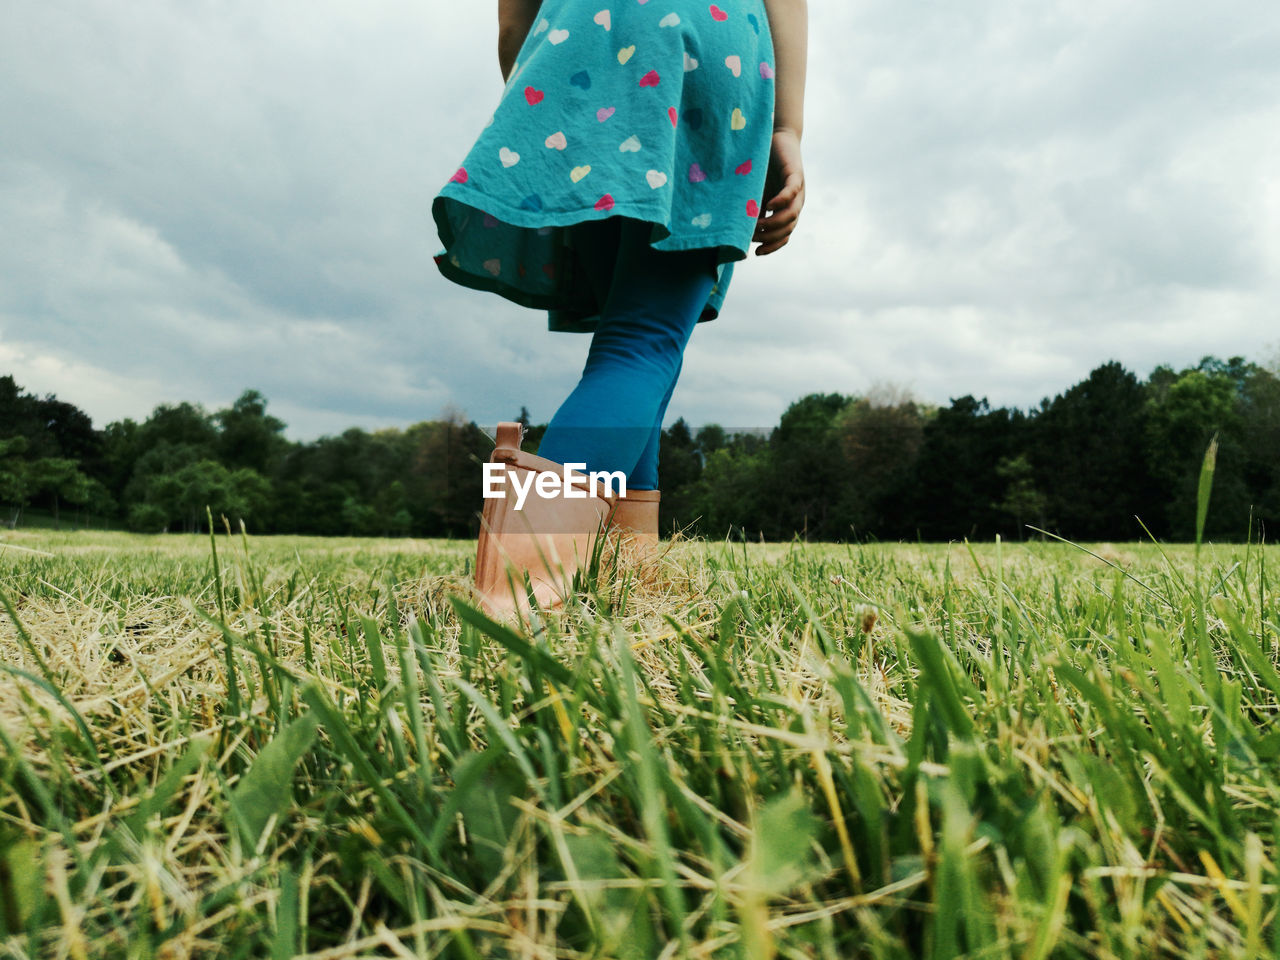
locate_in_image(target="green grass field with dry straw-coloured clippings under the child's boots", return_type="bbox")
[0,532,1280,960]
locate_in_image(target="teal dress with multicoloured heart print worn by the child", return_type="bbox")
[431,0,774,332]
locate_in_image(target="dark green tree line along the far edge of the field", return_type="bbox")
[0,357,1280,541]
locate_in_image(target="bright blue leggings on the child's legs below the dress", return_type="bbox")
[538,218,716,490]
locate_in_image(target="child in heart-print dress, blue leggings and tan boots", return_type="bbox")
[433,0,808,611]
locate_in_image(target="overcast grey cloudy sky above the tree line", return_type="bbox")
[0,0,1280,439]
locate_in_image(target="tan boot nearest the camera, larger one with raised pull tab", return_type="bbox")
[476,422,622,616]
